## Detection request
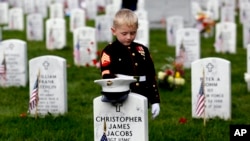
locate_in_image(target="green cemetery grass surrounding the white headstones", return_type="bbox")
[0,17,250,141]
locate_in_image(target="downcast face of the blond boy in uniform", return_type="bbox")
[111,25,137,46]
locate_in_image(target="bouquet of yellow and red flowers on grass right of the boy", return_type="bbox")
[158,57,185,90]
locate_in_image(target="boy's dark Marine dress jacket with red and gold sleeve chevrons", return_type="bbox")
[101,40,160,104]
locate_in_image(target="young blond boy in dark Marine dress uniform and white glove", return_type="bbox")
[101,9,160,118]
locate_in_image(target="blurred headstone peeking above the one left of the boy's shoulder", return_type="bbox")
[70,8,86,32]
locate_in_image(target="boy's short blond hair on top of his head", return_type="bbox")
[113,8,138,28]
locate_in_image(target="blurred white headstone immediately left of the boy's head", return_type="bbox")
[95,14,113,42]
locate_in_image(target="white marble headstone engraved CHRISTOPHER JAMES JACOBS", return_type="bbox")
[93,93,148,141]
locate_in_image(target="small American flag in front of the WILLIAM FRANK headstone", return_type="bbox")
[29,74,39,110]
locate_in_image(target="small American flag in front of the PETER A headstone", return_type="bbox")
[195,81,205,117]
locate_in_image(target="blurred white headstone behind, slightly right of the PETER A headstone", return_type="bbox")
[214,22,236,54]
